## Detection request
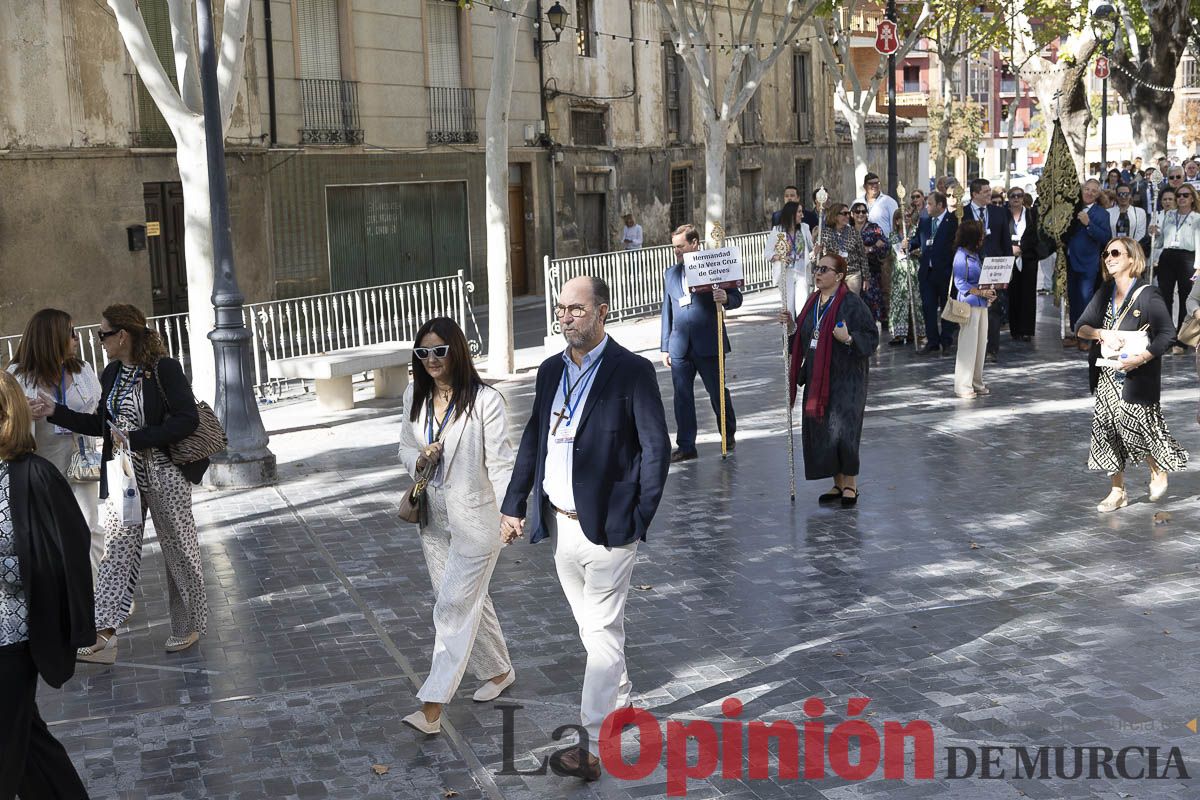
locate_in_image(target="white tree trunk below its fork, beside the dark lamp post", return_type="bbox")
[172,116,217,404]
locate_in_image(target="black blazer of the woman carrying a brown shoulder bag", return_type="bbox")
[48,359,209,500]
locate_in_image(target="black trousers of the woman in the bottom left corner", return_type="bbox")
[0,643,88,800]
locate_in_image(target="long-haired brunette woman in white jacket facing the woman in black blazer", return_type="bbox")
[8,308,104,581]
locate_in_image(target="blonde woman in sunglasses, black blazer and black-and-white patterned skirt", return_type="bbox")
[1075,237,1188,512]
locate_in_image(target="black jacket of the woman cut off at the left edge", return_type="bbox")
[8,455,96,688]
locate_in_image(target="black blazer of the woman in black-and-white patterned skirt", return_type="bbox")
[1075,281,1175,405]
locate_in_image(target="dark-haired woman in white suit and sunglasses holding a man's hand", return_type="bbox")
[400,317,516,734]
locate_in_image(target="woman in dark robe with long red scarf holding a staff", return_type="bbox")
[779,253,880,509]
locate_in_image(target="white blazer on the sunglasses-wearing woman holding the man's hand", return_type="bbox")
[398,384,516,552]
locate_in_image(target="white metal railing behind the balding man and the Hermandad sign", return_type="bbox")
[544,231,775,337]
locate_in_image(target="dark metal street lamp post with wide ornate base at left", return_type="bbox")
[196,0,275,487]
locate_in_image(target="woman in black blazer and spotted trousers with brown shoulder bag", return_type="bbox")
[34,303,209,663]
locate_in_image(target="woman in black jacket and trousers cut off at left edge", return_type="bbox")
[0,373,92,800]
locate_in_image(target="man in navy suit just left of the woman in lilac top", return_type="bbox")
[908,192,959,355]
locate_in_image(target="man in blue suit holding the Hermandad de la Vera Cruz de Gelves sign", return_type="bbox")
[659,225,742,462]
